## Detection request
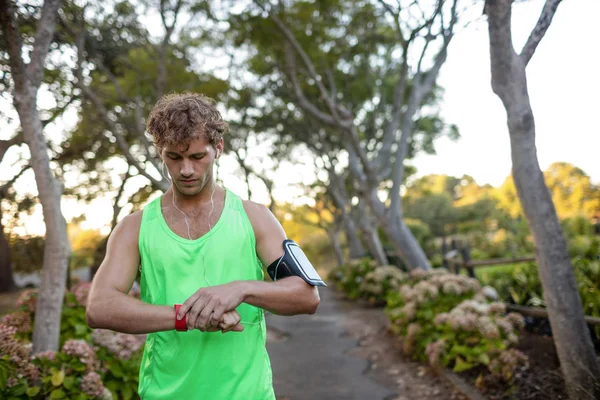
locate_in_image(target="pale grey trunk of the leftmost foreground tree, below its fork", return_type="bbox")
[14,89,71,353]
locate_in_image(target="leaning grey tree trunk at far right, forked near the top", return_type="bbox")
[486,0,600,399]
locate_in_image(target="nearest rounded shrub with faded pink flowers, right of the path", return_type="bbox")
[386,270,527,380]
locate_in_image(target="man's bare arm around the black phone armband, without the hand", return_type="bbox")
[240,201,320,315]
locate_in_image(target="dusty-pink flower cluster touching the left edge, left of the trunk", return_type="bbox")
[0,324,39,387]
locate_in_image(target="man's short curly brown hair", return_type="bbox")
[146,93,229,152]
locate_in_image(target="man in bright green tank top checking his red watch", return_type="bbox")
[87,94,324,400]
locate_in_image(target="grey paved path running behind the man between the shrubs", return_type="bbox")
[267,288,394,400]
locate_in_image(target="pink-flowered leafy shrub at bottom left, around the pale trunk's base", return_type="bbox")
[0,283,145,400]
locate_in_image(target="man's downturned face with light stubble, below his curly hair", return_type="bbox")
[161,135,223,196]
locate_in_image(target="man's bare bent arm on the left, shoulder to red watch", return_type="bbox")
[86,211,175,334]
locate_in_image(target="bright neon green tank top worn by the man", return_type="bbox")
[139,191,275,400]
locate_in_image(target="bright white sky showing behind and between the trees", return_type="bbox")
[0,0,600,234]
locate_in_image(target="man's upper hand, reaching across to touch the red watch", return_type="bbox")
[178,282,244,332]
